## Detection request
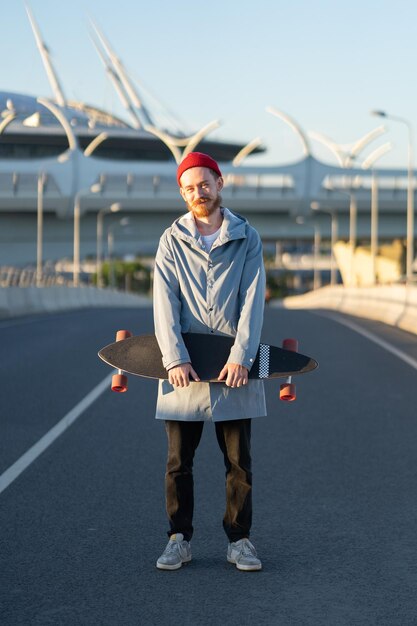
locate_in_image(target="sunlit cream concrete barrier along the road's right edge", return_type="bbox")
[282,285,417,334]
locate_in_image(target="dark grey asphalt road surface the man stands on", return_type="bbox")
[0,308,417,626]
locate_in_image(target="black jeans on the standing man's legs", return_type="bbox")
[165,419,252,541]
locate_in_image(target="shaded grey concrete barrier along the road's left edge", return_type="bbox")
[0,287,151,319]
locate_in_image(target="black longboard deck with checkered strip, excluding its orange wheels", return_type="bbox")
[98,333,318,382]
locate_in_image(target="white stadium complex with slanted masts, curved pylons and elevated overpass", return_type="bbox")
[0,10,414,286]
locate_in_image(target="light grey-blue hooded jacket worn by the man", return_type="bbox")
[154,209,266,421]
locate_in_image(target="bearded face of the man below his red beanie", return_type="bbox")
[180,167,223,217]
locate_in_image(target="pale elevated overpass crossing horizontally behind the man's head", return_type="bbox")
[0,151,416,265]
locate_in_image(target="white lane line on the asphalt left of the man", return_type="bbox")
[0,374,113,493]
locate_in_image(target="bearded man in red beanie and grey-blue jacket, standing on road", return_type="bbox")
[154,152,266,571]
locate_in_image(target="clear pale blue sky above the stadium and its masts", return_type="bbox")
[0,0,417,167]
